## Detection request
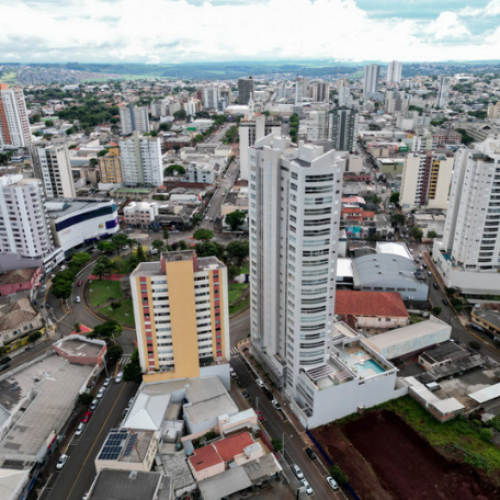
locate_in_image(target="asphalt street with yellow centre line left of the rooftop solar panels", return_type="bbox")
[40,382,137,500]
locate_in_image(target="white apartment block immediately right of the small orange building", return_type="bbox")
[120,132,163,186]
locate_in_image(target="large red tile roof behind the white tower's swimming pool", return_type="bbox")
[335,290,409,318]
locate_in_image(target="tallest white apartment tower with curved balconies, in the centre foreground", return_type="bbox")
[249,135,344,398]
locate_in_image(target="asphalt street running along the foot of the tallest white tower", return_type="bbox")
[231,354,343,499]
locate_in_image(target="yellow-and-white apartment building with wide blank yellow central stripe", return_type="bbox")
[130,250,230,381]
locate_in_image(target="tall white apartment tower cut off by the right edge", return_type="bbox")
[443,140,500,271]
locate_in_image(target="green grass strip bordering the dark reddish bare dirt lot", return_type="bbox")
[377,396,500,473]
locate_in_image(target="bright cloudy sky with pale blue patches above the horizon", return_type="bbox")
[0,0,500,64]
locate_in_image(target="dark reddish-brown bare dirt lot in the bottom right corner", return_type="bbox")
[313,410,500,500]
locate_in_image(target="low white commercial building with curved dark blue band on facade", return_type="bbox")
[46,198,120,252]
